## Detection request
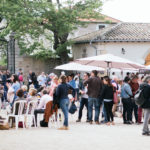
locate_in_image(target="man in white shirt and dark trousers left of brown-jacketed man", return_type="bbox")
[76,73,90,122]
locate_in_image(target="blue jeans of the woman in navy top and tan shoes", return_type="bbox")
[60,99,69,127]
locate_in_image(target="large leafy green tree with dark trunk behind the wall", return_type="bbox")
[0,0,102,63]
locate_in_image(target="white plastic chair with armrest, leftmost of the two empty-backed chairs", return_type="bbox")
[8,100,27,129]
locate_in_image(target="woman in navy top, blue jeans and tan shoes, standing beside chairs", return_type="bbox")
[56,75,74,130]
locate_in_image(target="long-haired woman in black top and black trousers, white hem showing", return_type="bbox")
[101,76,114,125]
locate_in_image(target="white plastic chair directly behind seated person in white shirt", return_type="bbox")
[25,100,38,128]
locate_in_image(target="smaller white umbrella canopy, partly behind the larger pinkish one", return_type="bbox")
[55,62,105,71]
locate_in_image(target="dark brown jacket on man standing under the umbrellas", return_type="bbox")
[84,77,102,98]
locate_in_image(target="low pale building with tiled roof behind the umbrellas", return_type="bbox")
[73,22,150,65]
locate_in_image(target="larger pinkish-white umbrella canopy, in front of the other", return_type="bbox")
[74,54,145,70]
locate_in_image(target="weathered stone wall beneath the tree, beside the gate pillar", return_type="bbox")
[15,42,61,79]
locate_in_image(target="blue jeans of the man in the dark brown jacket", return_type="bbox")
[88,97,101,122]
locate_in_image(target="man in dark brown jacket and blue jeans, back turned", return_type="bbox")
[84,70,102,124]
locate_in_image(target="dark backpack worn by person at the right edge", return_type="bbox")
[134,86,146,106]
